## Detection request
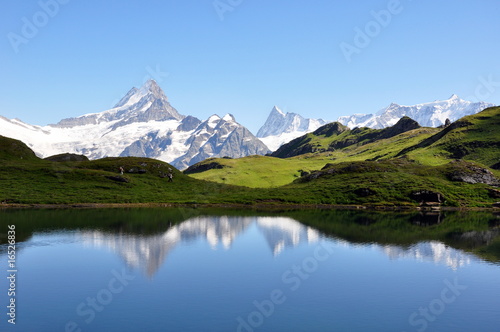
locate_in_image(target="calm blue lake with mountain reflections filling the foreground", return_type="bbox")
[0,209,500,332]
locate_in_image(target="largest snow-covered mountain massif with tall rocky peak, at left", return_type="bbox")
[0,80,270,169]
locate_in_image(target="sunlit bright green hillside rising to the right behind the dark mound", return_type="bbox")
[191,107,500,188]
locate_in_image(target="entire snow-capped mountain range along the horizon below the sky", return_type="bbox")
[0,80,492,169]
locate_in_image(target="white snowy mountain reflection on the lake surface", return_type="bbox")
[77,216,472,277]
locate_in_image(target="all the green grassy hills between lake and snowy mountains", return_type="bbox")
[0,107,500,207]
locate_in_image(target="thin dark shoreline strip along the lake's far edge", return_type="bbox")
[0,203,500,212]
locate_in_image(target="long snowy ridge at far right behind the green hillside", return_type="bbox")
[337,94,494,129]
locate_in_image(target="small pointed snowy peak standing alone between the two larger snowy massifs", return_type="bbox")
[257,106,327,151]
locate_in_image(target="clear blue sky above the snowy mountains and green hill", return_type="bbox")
[0,0,500,133]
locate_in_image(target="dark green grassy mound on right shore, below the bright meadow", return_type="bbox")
[282,159,494,207]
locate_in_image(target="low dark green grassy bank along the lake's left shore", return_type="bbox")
[0,148,258,204]
